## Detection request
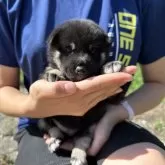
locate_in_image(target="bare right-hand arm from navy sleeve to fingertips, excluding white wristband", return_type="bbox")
[89,57,165,155]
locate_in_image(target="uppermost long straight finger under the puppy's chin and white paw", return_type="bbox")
[76,72,132,93]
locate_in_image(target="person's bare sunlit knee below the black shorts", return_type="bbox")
[103,143,165,165]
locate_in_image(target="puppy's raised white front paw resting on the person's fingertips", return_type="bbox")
[102,61,124,74]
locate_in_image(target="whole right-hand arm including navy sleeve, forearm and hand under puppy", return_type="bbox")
[90,0,165,154]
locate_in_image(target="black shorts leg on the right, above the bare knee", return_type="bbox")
[97,122,165,165]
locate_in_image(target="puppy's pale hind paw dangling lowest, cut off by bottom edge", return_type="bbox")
[70,148,88,165]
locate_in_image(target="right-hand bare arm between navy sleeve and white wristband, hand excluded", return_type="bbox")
[126,57,165,115]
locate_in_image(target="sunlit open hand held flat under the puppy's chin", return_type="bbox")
[24,66,136,118]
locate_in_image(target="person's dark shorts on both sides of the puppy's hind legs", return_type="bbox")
[16,122,165,165]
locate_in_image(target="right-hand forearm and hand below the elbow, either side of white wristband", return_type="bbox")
[89,83,165,155]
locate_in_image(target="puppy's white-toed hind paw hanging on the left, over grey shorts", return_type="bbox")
[48,137,61,153]
